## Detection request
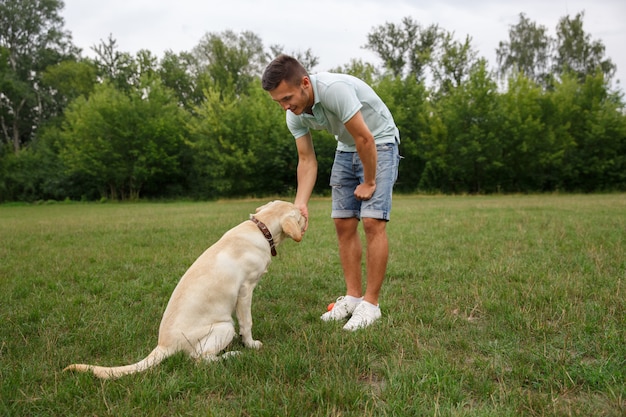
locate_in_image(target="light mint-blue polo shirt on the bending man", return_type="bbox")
[286,72,400,152]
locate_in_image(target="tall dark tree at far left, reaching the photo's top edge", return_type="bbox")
[0,0,78,152]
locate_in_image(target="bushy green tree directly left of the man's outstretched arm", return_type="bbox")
[190,79,296,198]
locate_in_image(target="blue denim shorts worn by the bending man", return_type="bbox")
[330,143,400,221]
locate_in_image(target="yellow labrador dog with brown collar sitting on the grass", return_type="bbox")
[65,201,306,379]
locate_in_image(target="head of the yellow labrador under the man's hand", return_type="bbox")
[255,200,306,243]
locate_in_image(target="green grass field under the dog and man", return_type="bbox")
[0,194,626,417]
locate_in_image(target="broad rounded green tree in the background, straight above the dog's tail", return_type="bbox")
[61,77,186,199]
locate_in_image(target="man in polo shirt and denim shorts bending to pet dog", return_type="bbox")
[262,55,400,331]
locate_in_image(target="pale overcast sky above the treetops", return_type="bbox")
[61,0,626,91]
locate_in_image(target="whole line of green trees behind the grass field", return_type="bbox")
[0,0,626,202]
